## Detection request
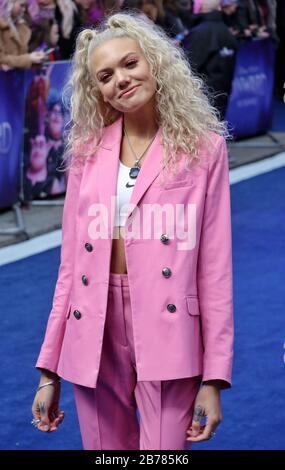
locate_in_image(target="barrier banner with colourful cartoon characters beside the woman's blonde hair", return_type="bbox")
[22,62,69,200]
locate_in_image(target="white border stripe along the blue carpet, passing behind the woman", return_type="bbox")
[0,152,285,266]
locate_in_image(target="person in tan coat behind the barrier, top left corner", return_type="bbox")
[0,0,46,70]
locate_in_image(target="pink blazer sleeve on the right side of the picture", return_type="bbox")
[197,137,234,388]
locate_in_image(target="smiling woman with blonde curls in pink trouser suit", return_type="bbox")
[32,14,232,449]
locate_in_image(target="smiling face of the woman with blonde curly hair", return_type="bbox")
[90,37,156,113]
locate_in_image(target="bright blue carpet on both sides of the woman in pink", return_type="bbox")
[0,168,285,449]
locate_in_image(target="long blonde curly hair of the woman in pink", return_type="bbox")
[65,12,228,173]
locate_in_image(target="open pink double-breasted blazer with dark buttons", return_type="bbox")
[36,118,233,387]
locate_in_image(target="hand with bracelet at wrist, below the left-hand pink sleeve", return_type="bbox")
[32,376,64,432]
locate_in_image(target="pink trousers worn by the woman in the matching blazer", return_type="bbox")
[74,273,201,450]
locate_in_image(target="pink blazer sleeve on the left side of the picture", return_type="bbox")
[36,165,82,372]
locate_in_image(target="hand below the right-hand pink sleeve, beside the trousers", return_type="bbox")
[186,384,222,442]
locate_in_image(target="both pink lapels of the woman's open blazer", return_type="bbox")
[98,117,163,227]
